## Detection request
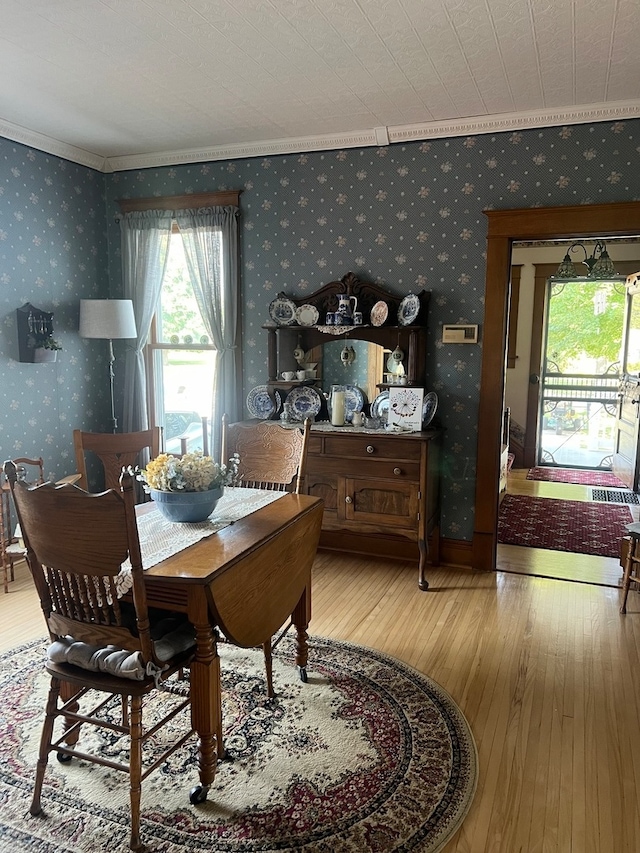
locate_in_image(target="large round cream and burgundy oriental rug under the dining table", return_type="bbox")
[0,637,477,853]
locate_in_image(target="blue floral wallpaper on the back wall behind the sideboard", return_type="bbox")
[107,120,640,540]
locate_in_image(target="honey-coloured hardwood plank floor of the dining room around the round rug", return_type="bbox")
[0,548,640,853]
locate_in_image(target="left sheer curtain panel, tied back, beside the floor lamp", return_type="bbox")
[120,210,174,432]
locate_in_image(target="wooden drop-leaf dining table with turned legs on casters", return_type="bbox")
[137,489,323,803]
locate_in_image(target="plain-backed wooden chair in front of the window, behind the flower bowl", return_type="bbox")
[73,427,161,491]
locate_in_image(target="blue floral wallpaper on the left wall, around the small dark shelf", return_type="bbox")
[0,139,110,478]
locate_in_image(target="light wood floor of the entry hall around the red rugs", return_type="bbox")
[498,468,640,587]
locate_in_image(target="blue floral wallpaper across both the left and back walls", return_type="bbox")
[0,120,640,540]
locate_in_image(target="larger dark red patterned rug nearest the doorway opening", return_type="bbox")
[498,495,633,557]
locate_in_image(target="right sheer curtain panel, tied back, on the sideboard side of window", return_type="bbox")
[175,206,239,448]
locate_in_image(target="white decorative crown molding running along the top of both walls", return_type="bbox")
[0,100,640,172]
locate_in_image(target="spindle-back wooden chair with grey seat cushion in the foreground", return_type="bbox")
[4,462,195,850]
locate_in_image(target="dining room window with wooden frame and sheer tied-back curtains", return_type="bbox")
[118,190,240,455]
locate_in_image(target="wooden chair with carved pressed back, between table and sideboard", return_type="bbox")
[220,415,311,698]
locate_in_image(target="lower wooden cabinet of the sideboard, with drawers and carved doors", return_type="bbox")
[305,426,441,590]
